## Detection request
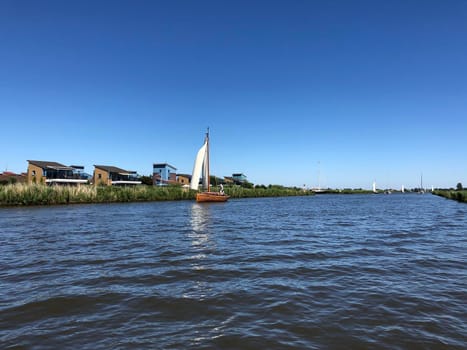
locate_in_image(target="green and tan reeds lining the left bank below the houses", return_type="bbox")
[0,183,311,206]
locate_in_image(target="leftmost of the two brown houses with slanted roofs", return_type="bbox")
[27,160,91,185]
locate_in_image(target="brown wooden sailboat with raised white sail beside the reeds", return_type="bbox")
[190,128,230,202]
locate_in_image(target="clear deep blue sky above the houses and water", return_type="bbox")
[0,0,467,188]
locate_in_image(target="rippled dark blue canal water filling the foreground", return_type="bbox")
[0,194,467,349]
